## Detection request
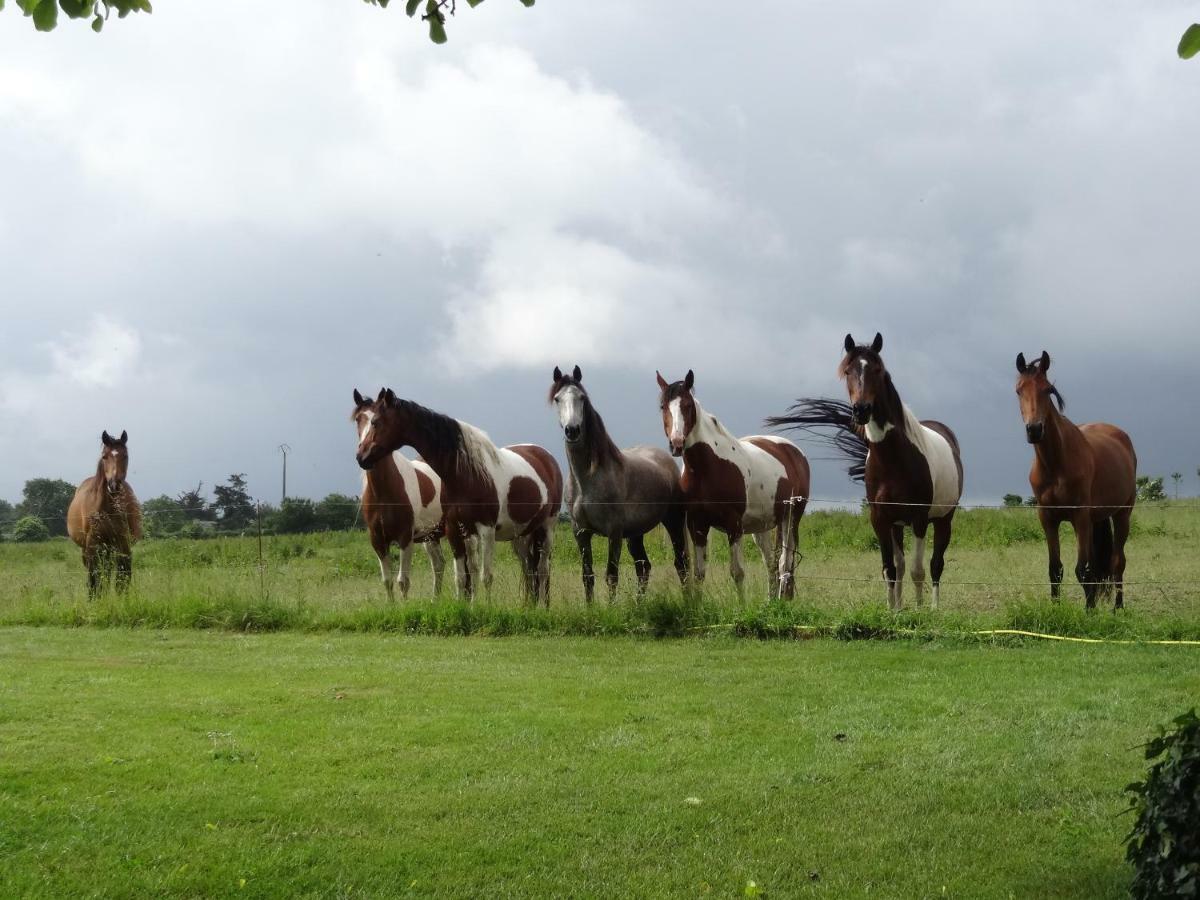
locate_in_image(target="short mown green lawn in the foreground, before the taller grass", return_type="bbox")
[0,628,1200,898]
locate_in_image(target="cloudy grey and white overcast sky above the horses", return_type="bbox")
[0,0,1200,502]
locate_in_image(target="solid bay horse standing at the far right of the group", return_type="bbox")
[1016,350,1138,610]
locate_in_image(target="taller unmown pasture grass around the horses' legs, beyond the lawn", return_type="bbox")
[0,502,1200,638]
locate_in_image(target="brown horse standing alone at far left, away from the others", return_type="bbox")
[67,431,142,599]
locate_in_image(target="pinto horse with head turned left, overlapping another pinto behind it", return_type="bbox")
[358,388,563,607]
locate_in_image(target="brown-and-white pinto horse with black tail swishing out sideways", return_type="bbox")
[768,334,962,610]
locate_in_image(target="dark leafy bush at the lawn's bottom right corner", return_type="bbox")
[1126,709,1200,900]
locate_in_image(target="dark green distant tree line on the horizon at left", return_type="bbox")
[0,473,362,541]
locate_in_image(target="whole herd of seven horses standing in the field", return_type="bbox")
[60,334,1136,610]
